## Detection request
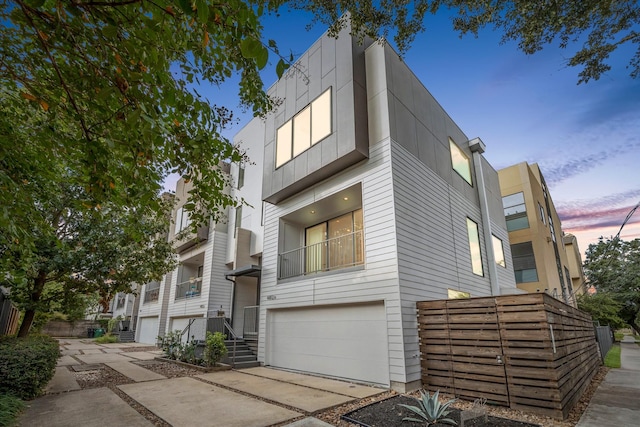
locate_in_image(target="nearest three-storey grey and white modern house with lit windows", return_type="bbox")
[250,26,519,390]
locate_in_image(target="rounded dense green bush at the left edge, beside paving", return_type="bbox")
[0,335,60,399]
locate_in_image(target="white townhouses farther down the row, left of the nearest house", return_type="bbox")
[136,139,263,344]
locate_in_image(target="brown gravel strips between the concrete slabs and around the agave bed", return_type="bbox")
[74,362,608,427]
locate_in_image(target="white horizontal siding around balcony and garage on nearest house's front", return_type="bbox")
[258,140,404,382]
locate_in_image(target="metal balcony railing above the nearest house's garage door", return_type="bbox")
[278,230,364,279]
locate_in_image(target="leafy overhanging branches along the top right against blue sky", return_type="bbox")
[289,0,640,83]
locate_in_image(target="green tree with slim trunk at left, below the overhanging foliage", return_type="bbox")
[0,176,175,337]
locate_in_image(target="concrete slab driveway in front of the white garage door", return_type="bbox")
[19,340,385,427]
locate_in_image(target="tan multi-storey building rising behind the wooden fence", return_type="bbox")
[498,162,578,306]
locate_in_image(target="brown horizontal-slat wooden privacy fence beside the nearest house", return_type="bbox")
[417,294,600,419]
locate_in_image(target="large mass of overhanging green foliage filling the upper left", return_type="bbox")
[0,0,286,251]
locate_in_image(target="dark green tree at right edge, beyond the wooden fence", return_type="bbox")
[584,237,640,333]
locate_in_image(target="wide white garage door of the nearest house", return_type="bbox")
[266,303,389,385]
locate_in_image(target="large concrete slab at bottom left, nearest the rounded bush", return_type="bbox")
[19,388,153,427]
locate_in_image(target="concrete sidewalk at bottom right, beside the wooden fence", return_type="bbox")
[576,335,640,427]
